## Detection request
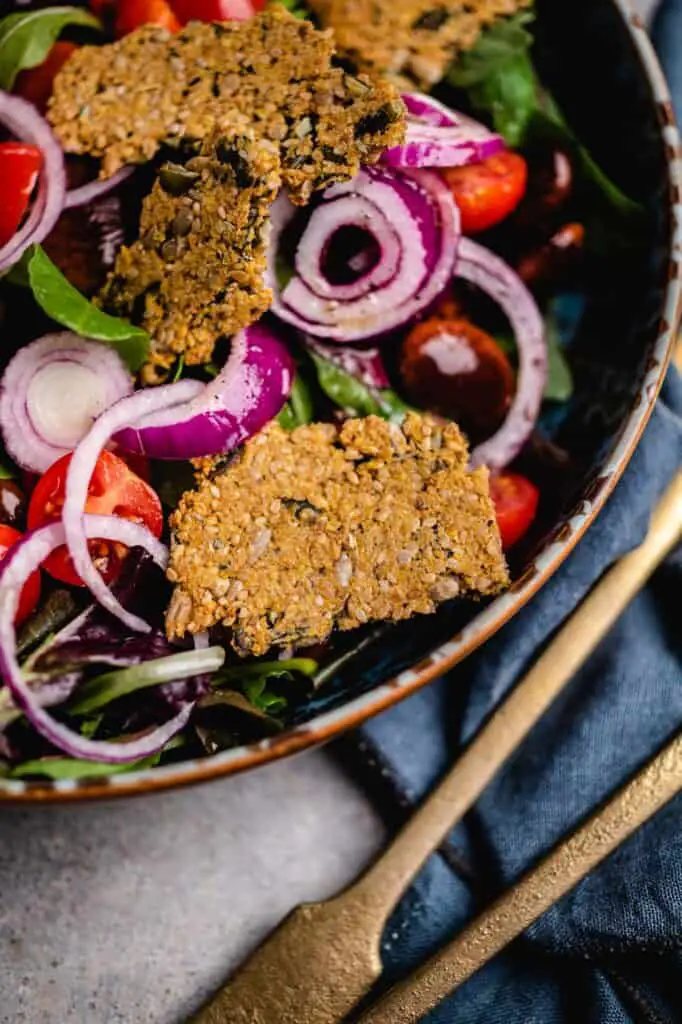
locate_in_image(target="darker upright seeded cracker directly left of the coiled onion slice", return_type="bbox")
[100,127,281,383]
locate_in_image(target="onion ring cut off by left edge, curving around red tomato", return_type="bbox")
[0,91,67,273]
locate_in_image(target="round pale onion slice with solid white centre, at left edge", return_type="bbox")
[0,331,132,473]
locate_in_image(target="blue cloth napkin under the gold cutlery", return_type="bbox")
[346,6,682,1024]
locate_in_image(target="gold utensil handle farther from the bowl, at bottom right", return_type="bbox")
[360,735,682,1024]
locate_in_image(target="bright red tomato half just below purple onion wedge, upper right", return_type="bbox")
[442,153,528,234]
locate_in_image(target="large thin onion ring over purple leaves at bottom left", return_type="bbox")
[0,515,194,764]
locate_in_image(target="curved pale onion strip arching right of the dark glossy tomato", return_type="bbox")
[456,239,547,469]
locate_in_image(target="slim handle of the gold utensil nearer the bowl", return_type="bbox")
[340,473,682,915]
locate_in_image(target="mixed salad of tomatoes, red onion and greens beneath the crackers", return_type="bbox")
[0,0,641,779]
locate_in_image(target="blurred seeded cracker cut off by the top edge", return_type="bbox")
[306,0,530,87]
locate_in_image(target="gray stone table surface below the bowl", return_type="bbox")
[0,0,654,1024]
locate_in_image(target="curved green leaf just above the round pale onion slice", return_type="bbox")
[26,246,150,370]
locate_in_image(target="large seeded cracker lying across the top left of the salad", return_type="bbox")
[49,7,404,203]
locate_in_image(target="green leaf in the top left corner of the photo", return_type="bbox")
[0,7,101,92]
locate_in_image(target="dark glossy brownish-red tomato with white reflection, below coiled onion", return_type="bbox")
[400,316,515,439]
